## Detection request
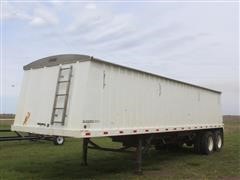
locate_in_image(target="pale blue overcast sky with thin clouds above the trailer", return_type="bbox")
[0,1,240,114]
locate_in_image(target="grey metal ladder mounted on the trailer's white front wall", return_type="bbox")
[51,66,72,125]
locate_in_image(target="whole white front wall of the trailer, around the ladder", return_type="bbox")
[12,61,90,136]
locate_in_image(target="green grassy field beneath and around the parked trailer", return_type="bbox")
[0,120,240,179]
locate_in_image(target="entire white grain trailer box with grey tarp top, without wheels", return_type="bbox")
[12,55,223,138]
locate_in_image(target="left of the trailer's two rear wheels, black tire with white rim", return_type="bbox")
[200,131,214,155]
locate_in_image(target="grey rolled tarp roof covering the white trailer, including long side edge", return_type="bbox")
[23,54,221,93]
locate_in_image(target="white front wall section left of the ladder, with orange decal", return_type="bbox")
[14,67,59,126]
